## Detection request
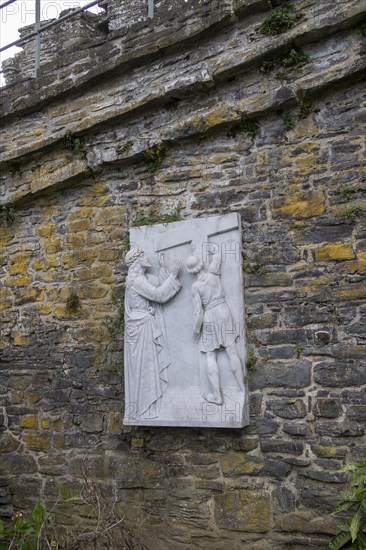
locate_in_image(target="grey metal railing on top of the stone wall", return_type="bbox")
[0,0,154,78]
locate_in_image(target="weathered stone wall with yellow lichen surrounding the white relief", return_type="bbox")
[0,0,366,550]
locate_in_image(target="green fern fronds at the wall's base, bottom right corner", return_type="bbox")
[328,449,366,550]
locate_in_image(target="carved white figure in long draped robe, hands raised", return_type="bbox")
[125,247,181,418]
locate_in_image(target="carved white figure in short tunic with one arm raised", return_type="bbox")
[186,247,244,405]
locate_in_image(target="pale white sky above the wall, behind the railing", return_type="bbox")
[0,0,101,85]
